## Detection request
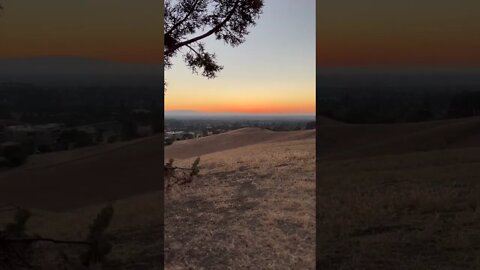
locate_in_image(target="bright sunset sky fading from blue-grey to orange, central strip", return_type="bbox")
[165,0,315,113]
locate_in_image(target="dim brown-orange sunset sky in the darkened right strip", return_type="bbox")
[317,0,480,67]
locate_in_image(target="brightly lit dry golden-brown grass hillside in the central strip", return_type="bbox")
[165,129,315,269]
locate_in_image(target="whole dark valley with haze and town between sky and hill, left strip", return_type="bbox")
[0,80,163,166]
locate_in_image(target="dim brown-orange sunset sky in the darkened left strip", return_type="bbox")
[0,0,163,63]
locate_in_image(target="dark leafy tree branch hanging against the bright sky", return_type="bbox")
[164,0,263,78]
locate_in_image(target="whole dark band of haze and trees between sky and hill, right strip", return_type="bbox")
[317,70,480,123]
